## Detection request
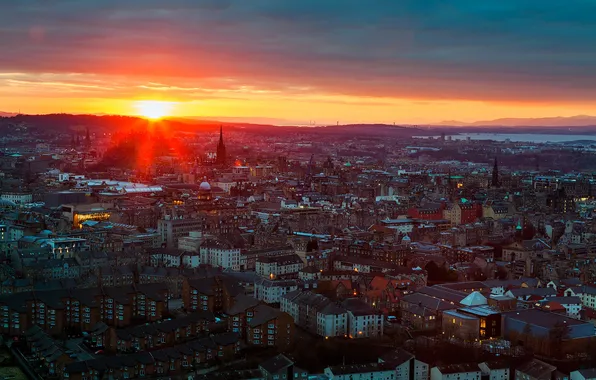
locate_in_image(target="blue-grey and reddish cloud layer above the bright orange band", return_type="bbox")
[0,0,596,101]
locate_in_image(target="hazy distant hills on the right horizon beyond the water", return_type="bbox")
[434,115,596,128]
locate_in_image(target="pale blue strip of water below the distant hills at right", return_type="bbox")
[414,133,596,145]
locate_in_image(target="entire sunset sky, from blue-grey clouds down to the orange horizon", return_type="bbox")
[0,0,596,125]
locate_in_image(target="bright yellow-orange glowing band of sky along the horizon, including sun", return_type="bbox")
[0,71,596,126]
